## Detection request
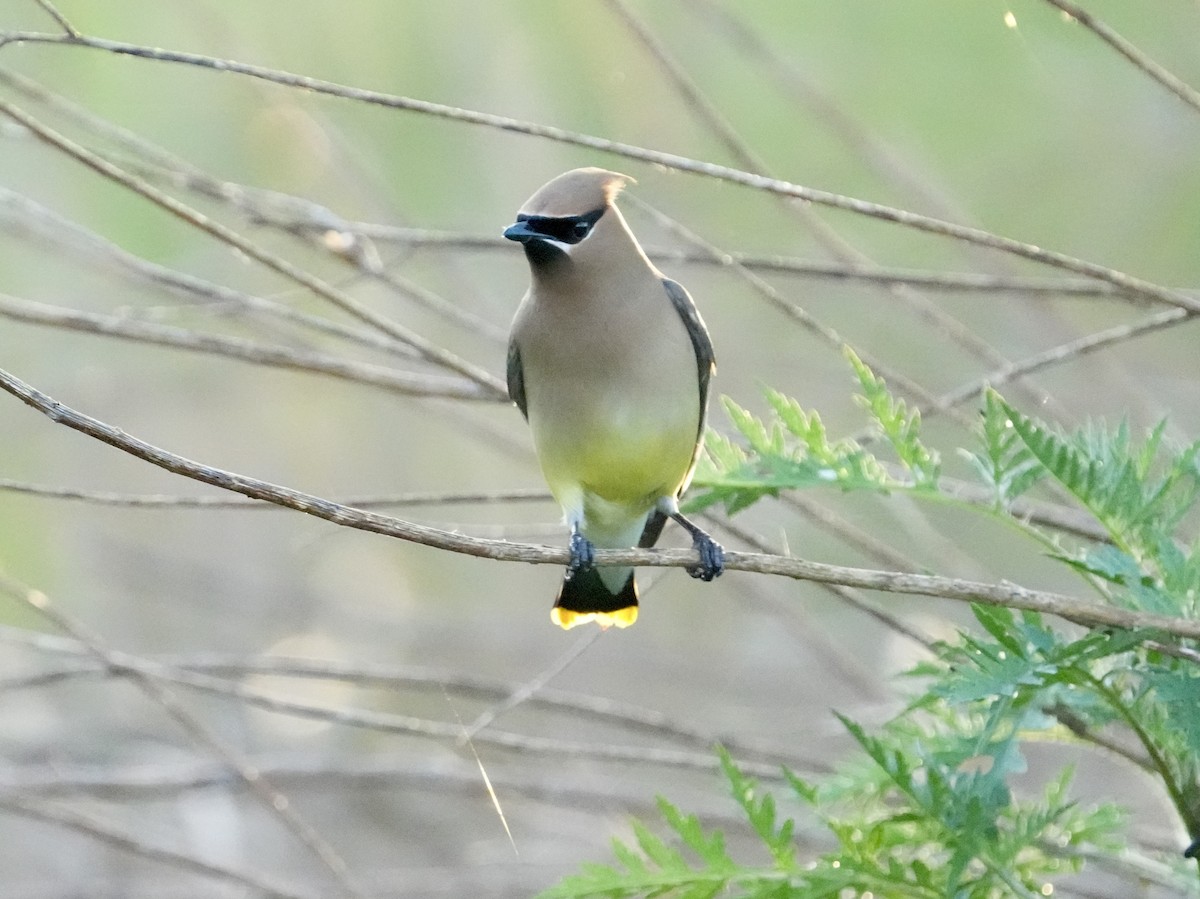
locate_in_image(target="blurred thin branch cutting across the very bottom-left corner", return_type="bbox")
[0,793,317,899]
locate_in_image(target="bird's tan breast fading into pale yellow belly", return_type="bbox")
[515,273,702,505]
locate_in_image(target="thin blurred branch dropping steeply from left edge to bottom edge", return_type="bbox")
[0,574,365,899]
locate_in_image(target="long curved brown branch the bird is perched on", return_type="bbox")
[0,370,1200,639]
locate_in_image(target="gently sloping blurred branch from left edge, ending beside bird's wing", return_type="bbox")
[0,294,500,402]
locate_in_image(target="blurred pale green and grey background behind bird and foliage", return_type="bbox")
[0,0,1200,899]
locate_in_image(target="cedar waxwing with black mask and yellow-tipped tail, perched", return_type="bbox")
[504,168,725,628]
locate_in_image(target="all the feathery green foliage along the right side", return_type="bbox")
[542,352,1200,899]
